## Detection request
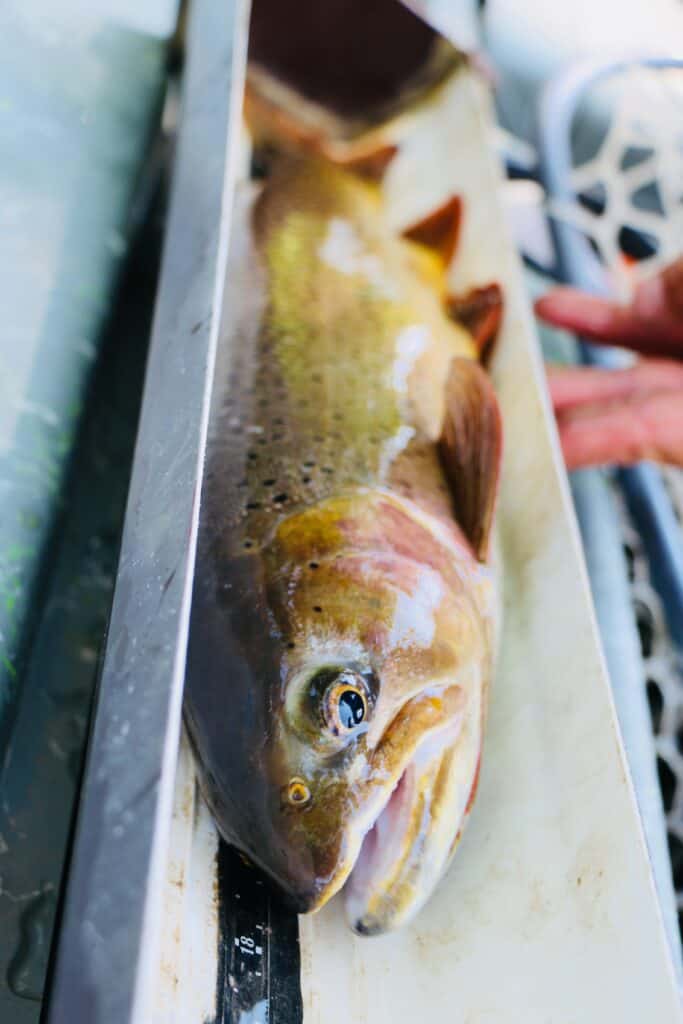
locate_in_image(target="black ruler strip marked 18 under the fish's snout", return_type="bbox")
[216,843,303,1024]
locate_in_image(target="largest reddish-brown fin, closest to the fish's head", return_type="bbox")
[438,358,503,561]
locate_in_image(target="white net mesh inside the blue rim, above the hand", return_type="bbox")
[549,66,683,297]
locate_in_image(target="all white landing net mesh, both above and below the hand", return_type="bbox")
[548,65,683,937]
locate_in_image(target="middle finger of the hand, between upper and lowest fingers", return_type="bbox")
[548,359,683,413]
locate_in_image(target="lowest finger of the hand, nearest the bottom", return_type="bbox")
[557,391,683,469]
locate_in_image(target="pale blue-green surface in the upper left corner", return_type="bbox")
[0,0,164,756]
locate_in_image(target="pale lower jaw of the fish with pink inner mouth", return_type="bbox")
[343,700,481,936]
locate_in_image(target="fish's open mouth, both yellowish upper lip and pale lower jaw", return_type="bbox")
[284,670,485,936]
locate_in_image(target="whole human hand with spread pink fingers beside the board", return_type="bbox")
[536,257,683,469]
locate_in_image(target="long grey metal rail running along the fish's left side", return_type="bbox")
[48,0,247,1024]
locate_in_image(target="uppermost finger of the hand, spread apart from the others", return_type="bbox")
[535,279,683,357]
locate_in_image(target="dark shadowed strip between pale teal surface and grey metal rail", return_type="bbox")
[0,180,160,1024]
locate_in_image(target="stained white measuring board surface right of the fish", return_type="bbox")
[300,68,682,1024]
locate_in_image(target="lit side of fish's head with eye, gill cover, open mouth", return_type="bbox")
[262,492,492,934]
